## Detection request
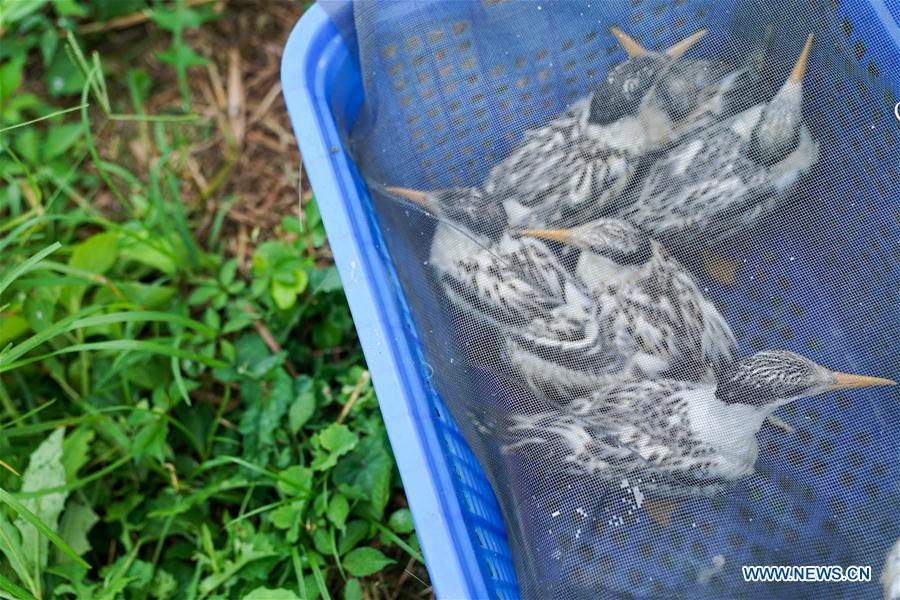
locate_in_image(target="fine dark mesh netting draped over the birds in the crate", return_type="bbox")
[336,0,900,598]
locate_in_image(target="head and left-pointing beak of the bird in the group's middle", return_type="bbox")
[518,219,653,265]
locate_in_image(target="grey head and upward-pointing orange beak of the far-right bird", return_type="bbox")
[750,34,813,166]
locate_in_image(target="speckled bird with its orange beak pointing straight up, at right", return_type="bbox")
[610,34,819,250]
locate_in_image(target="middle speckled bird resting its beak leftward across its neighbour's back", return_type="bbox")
[520,219,737,390]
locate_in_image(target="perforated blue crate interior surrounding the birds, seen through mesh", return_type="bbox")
[288,0,900,598]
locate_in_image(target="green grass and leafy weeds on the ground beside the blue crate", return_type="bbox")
[0,0,430,599]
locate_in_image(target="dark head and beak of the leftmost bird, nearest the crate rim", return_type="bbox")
[385,187,507,237]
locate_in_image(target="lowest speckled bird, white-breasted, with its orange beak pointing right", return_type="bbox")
[505,350,894,498]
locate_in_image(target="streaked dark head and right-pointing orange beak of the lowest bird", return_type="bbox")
[716,350,895,412]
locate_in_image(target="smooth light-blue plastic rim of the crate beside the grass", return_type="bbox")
[281,6,500,598]
